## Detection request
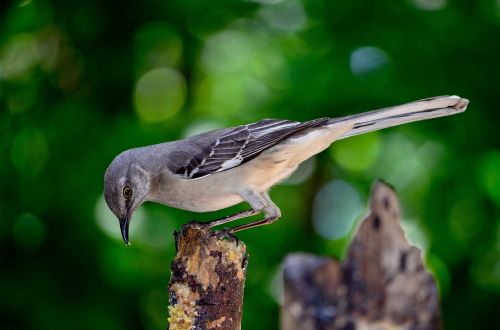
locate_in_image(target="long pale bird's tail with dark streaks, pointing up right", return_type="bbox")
[331,96,469,140]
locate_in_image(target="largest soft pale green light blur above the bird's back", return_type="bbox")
[194,20,289,116]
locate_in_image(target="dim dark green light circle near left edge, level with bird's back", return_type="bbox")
[12,128,49,177]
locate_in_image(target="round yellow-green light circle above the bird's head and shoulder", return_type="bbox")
[134,68,186,123]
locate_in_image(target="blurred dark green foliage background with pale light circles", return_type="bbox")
[0,0,500,330]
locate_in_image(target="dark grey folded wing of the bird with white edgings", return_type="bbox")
[169,118,329,179]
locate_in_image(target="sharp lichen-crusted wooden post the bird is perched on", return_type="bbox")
[168,223,247,330]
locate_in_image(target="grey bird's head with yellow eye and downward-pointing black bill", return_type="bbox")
[104,151,150,245]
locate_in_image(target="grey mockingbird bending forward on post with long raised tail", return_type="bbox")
[104,96,469,245]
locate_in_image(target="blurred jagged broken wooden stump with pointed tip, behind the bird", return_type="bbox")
[281,182,441,330]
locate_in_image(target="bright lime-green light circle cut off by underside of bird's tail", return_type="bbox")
[330,133,380,171]
